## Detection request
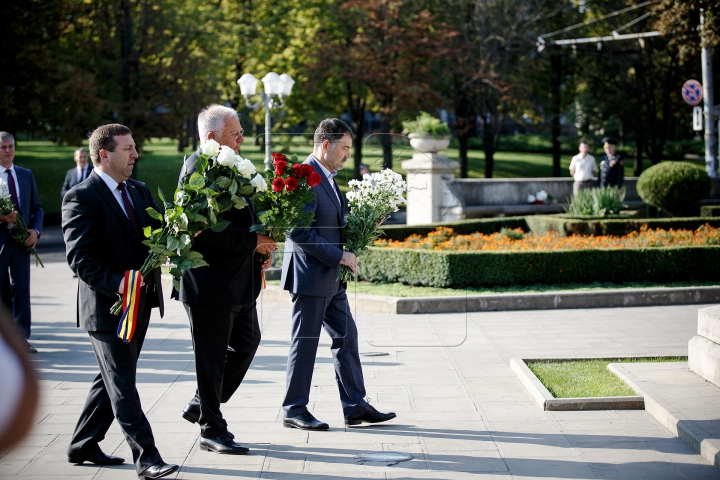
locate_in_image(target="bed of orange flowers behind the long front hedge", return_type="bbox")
[375,224,720,251]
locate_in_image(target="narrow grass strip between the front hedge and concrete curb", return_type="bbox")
[267,280,719,297]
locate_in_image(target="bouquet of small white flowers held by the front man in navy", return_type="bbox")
[339,169,407,282]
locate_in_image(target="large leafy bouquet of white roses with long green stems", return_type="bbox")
[110,140,267,315]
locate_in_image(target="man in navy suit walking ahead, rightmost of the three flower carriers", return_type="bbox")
[280,118,395,430]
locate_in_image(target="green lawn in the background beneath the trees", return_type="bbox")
[9,137,704,224]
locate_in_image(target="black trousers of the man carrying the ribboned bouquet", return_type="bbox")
[68,302,162,473]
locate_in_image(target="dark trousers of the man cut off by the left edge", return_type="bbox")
[0,239,30,338]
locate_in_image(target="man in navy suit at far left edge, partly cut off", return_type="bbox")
[0,132,44,353]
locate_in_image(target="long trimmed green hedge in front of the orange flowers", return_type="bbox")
[358,247,720,287]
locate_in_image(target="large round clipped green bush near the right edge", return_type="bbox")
[637,162,712,217]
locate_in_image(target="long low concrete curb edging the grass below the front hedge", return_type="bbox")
[261,285,720,315]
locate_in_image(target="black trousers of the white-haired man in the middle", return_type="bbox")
[184,302,260,438]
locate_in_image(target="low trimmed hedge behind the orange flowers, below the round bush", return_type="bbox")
[525,215,720,236]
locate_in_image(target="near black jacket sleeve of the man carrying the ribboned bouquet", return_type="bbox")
[62,188,123,297]
